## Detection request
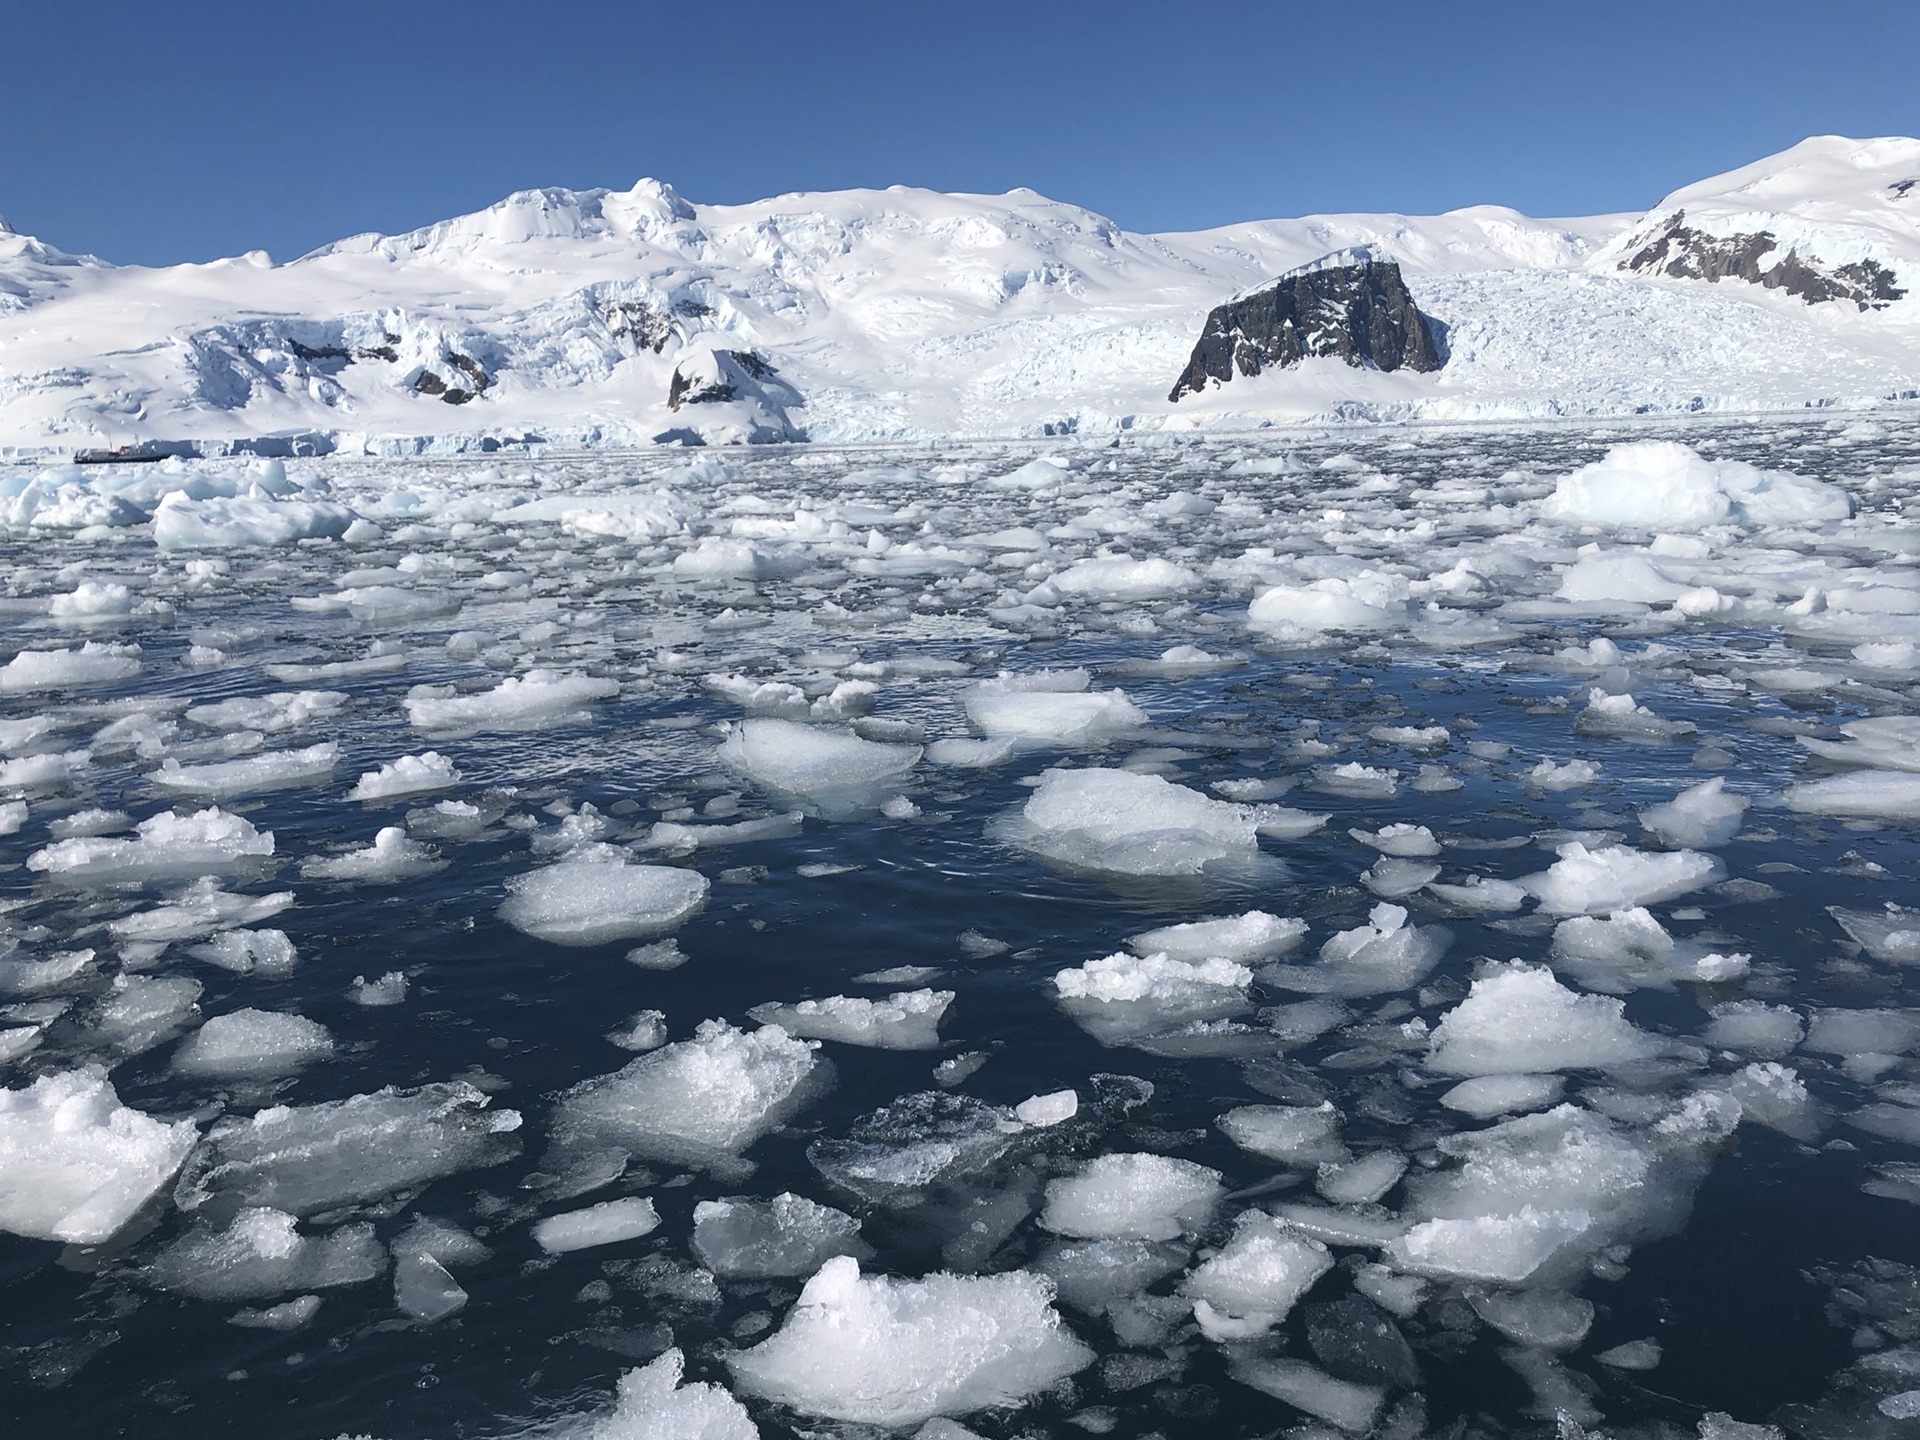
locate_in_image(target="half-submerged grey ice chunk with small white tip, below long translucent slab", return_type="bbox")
[144,1208,386,1300]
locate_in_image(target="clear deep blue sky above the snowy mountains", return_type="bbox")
[0,0,1920,263]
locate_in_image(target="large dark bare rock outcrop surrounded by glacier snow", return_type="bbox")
[1167,248,1444,401]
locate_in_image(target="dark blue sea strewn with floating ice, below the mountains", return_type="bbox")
[0,407,1920,1440]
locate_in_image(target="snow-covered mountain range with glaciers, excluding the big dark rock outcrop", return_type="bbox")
[0,136,1920,453]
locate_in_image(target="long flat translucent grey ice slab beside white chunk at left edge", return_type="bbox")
[173,1081,520,1215]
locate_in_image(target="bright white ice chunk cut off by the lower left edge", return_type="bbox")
[0,1066,200,1244]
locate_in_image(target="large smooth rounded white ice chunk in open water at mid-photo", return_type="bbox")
[1002,768,1261,876]
